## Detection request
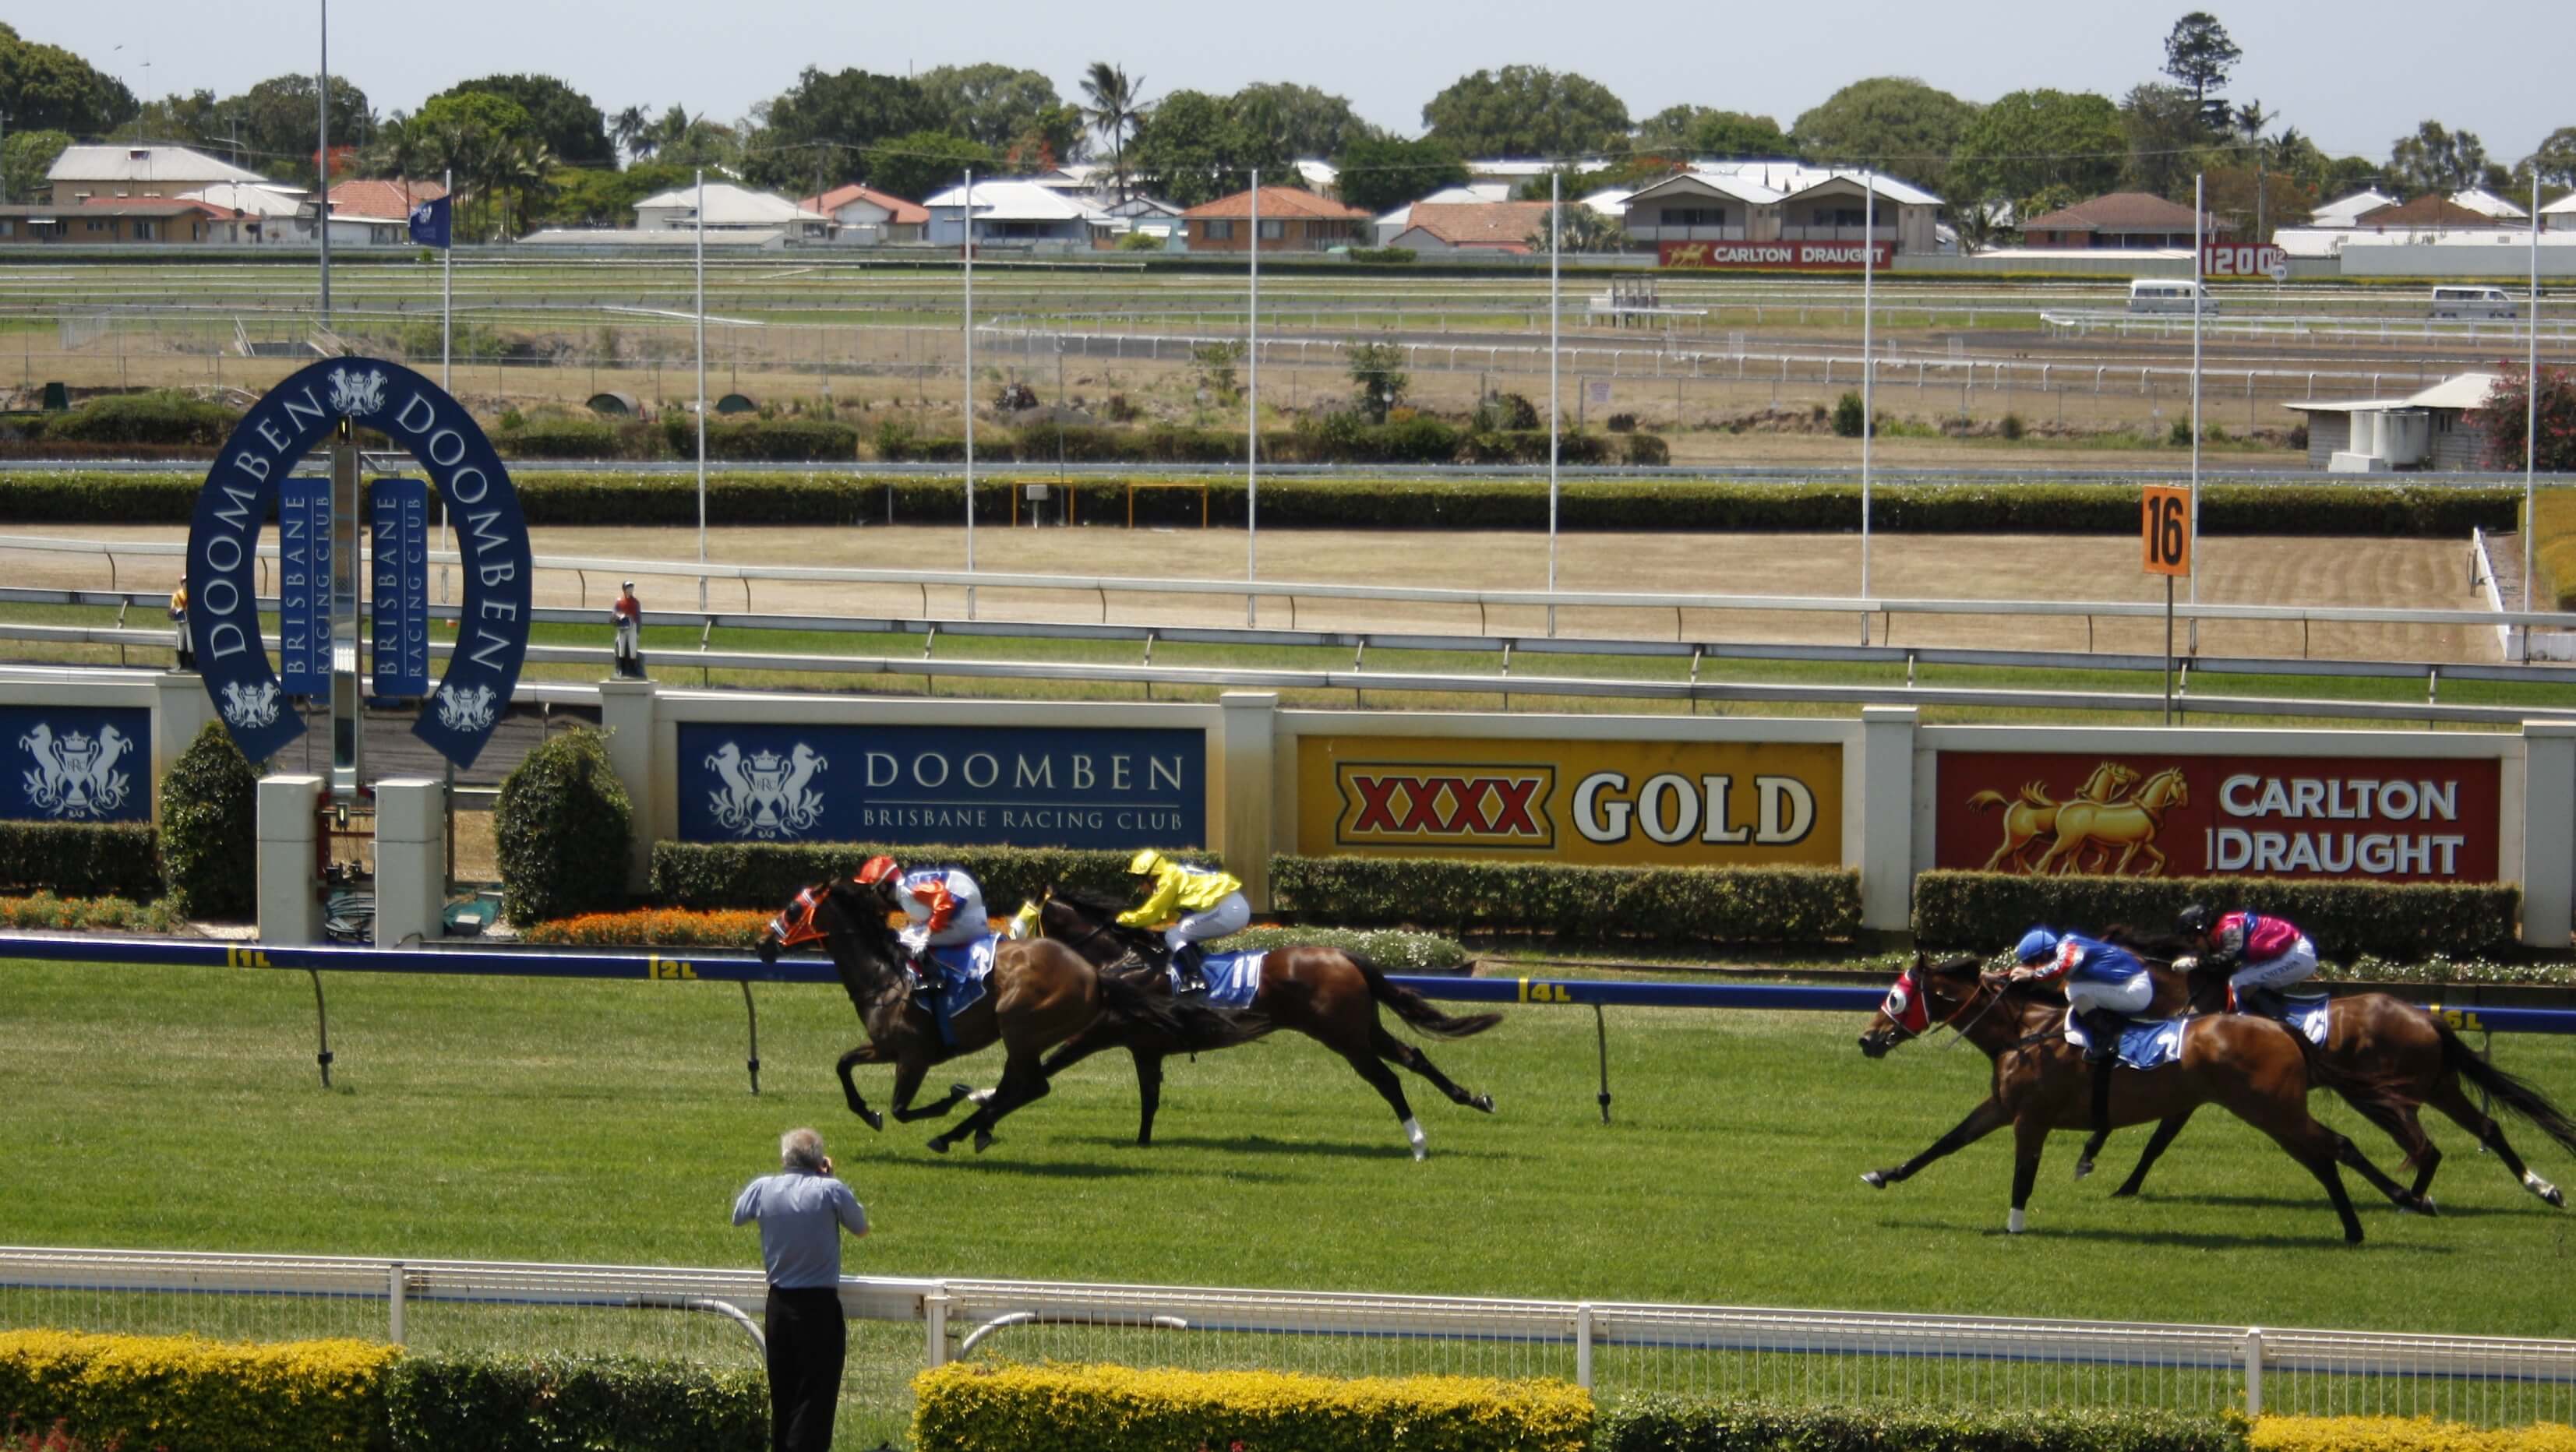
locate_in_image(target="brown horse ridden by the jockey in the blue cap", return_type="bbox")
[1860,957,2432,1243]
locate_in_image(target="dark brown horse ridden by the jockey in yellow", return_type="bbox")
[1038,888,1501,1158]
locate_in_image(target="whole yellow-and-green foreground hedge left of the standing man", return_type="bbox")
[0,1331,770,1452]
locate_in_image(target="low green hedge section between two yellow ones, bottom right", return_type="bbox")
[1592,1395,2246,1452]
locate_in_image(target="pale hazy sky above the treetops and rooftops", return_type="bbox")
[40,0,2576,165]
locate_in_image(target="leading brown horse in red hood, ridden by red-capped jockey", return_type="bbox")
[760,878,1203,1154]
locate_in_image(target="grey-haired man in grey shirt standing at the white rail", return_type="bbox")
[734,1130,868,1452]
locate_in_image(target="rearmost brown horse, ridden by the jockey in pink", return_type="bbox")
[2077,957,2576,1210]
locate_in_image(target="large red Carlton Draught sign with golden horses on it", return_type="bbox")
[1935,752,2504,883]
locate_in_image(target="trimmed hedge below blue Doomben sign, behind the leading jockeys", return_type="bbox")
[651,842,1223,919]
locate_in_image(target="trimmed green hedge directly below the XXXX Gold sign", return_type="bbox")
[1270,855,1860,943]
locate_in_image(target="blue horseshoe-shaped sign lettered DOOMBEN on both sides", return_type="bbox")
[188,358,533,767]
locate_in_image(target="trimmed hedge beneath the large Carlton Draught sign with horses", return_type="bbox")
[1914,872,2522,957]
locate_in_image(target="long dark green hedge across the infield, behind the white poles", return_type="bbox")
[0,468,2519,538]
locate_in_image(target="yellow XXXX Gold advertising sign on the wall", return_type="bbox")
[1298,736,1842,865]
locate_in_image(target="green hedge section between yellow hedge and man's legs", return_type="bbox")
[384,1354,770,1452]
